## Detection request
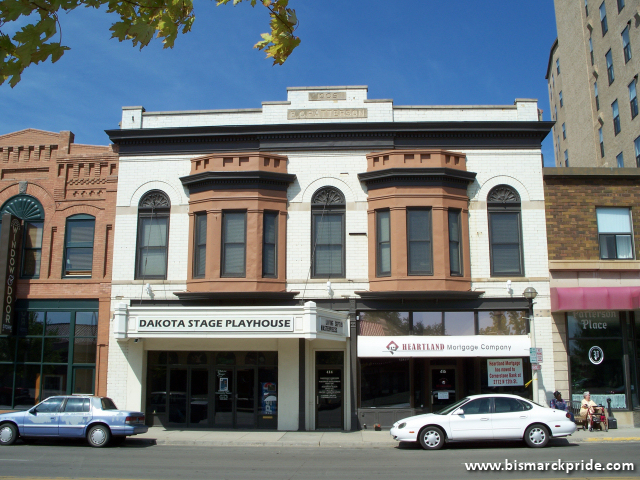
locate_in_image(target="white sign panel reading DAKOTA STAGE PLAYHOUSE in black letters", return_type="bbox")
[137,315,293,334]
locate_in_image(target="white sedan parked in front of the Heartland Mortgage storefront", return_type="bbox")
[390,394,576,450]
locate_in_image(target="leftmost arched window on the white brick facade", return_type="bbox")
[136,190,171,280]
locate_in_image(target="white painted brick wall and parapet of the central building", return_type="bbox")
[107,88,554,403]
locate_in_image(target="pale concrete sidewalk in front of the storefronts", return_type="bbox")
[130,427,640,448]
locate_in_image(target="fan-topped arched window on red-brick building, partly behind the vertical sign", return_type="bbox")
[0,195,44,278]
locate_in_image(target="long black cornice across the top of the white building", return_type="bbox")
[106,121,553,157]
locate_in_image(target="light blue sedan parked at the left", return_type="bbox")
[0,395,148,447]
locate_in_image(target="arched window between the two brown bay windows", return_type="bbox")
[311,187,346,278]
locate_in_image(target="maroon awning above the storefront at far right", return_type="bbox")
[551,287,640,312]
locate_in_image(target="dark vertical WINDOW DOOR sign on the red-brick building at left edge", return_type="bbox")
[0,213,22,335]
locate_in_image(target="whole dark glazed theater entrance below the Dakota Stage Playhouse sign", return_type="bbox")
[147,352,278,429]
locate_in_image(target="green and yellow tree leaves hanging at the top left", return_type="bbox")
[0,0,300,87]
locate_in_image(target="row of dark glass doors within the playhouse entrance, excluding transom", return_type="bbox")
[168,366,257,428]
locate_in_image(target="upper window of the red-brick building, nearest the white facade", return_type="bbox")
[63,215,96,277]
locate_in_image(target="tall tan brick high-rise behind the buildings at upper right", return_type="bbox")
[546,0,640,167]
